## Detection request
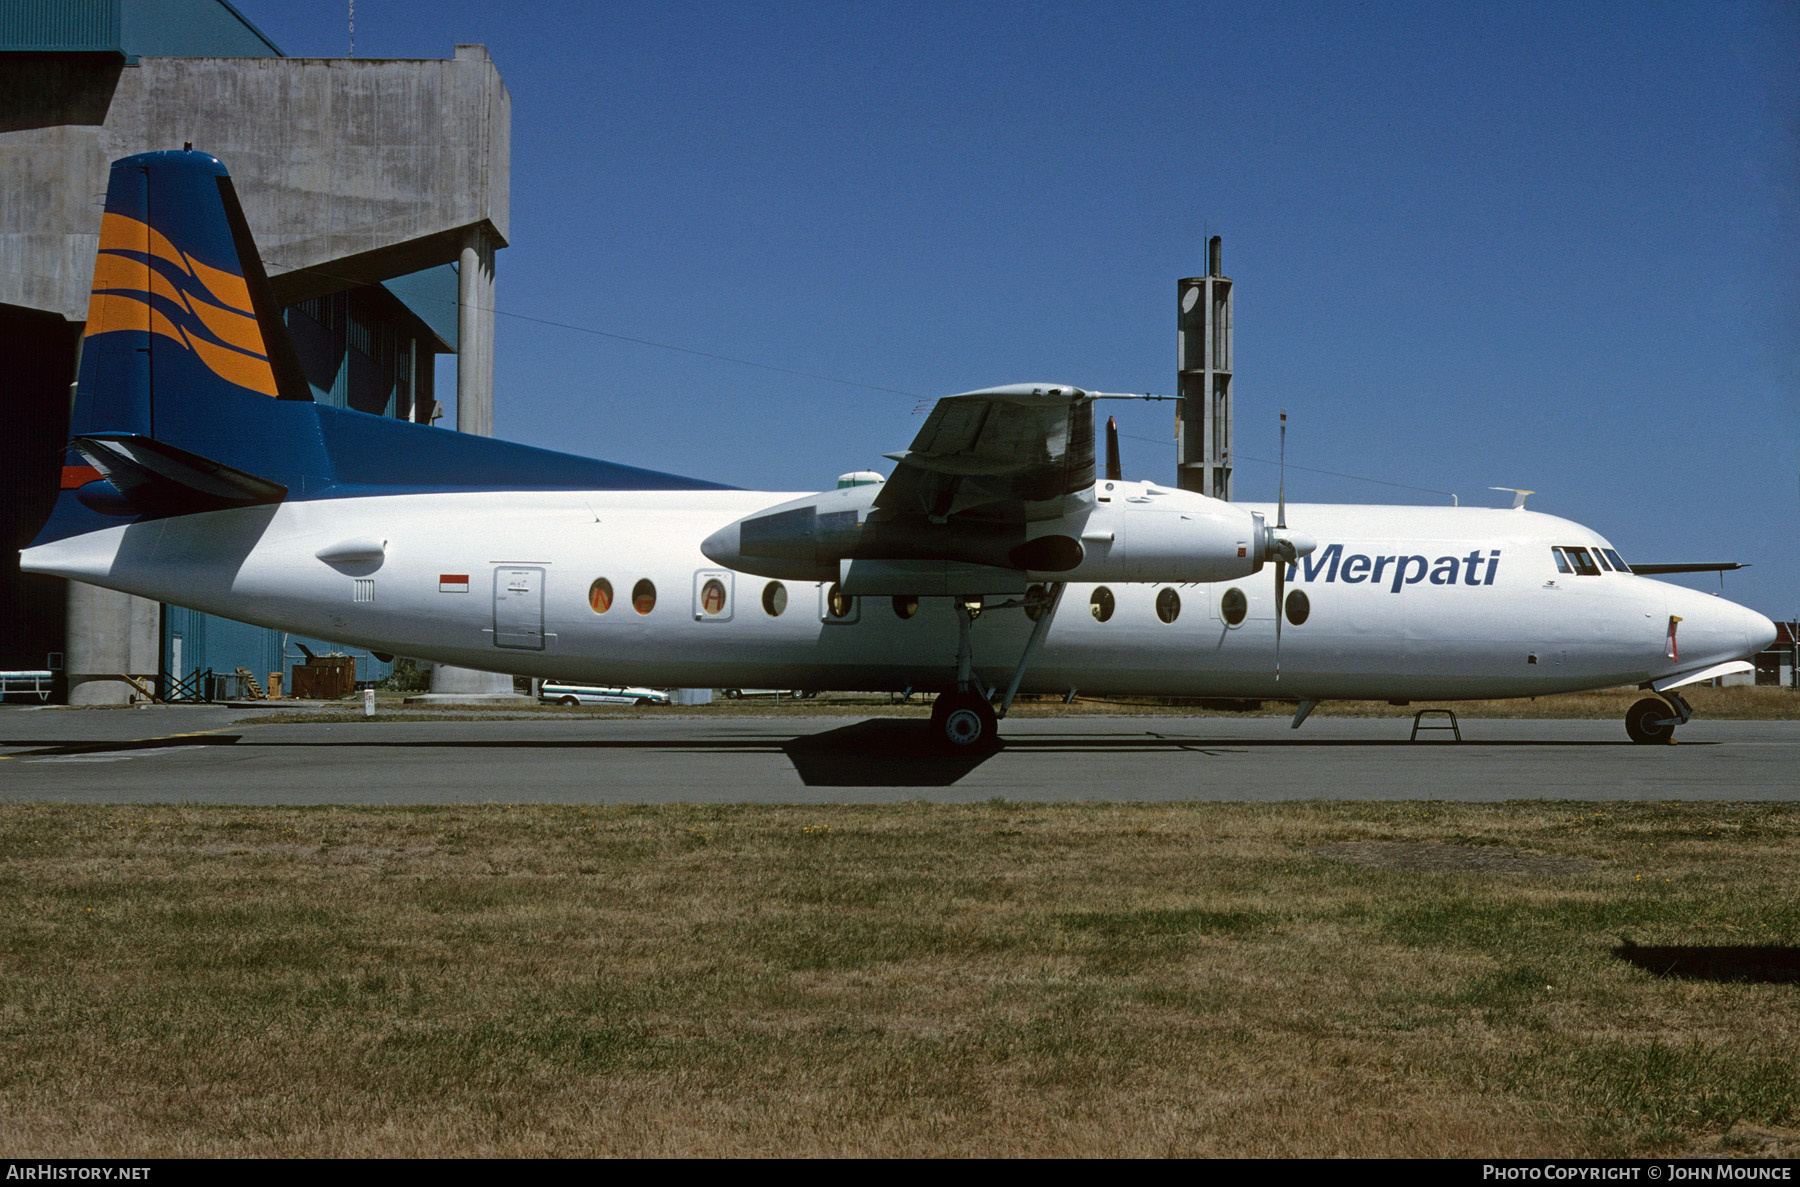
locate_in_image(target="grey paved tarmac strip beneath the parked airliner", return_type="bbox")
[0,706,1800,805]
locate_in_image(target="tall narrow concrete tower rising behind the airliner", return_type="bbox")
[1175,234,1231,499]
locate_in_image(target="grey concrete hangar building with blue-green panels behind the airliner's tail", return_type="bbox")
[0,0,511,704]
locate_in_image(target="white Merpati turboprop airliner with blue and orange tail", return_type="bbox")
[22,151,1775,748]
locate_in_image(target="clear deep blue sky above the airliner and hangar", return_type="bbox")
[239,0,1800,618]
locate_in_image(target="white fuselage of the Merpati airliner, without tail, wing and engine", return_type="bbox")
[23,485,1773,699]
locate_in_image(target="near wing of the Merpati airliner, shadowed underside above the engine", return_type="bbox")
[873,385,1094,524]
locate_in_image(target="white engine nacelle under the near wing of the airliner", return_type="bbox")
[700,481,1281,594]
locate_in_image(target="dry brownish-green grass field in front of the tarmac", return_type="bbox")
[0,803,1800,1156]
